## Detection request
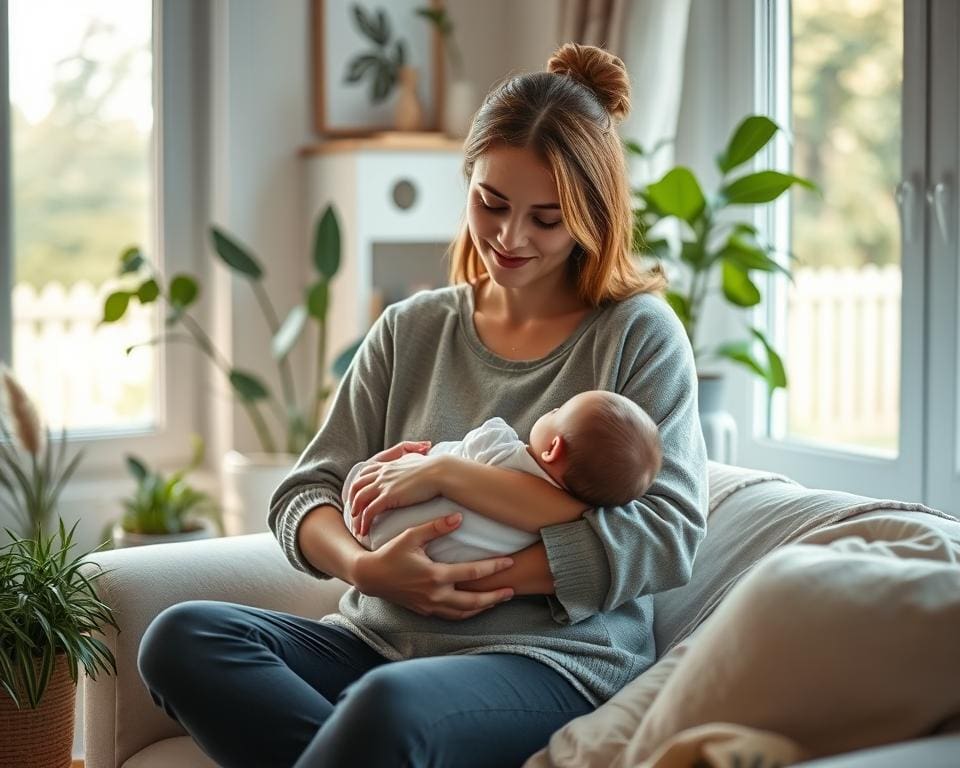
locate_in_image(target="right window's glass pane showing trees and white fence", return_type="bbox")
[787,0,903,454]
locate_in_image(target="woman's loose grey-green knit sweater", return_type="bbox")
[269,284,707,704]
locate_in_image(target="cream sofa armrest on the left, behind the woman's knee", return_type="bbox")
[83,533,347,768]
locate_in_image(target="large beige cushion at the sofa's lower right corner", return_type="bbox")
[526,511,960,768]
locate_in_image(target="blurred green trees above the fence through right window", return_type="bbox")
[792,0,903,267]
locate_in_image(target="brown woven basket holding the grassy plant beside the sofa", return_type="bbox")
[0,653,77,768]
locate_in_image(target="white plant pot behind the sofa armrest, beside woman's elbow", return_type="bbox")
[223,451,298,536]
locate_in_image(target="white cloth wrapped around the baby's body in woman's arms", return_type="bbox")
[342,418,557,563]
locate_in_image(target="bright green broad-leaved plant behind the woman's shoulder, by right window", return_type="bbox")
[625,115,816,400]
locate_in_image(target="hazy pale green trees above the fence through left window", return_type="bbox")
[11,24,152,289]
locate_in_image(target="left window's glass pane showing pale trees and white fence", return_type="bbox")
[9,0,156,429]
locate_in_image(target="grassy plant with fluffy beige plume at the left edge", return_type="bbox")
[0,365,82,536]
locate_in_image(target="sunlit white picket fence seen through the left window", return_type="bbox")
[13,282,156,429]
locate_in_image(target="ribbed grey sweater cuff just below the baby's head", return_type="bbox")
[540,519,610,624]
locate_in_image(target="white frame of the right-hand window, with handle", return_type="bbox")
[727,0,927,500]
